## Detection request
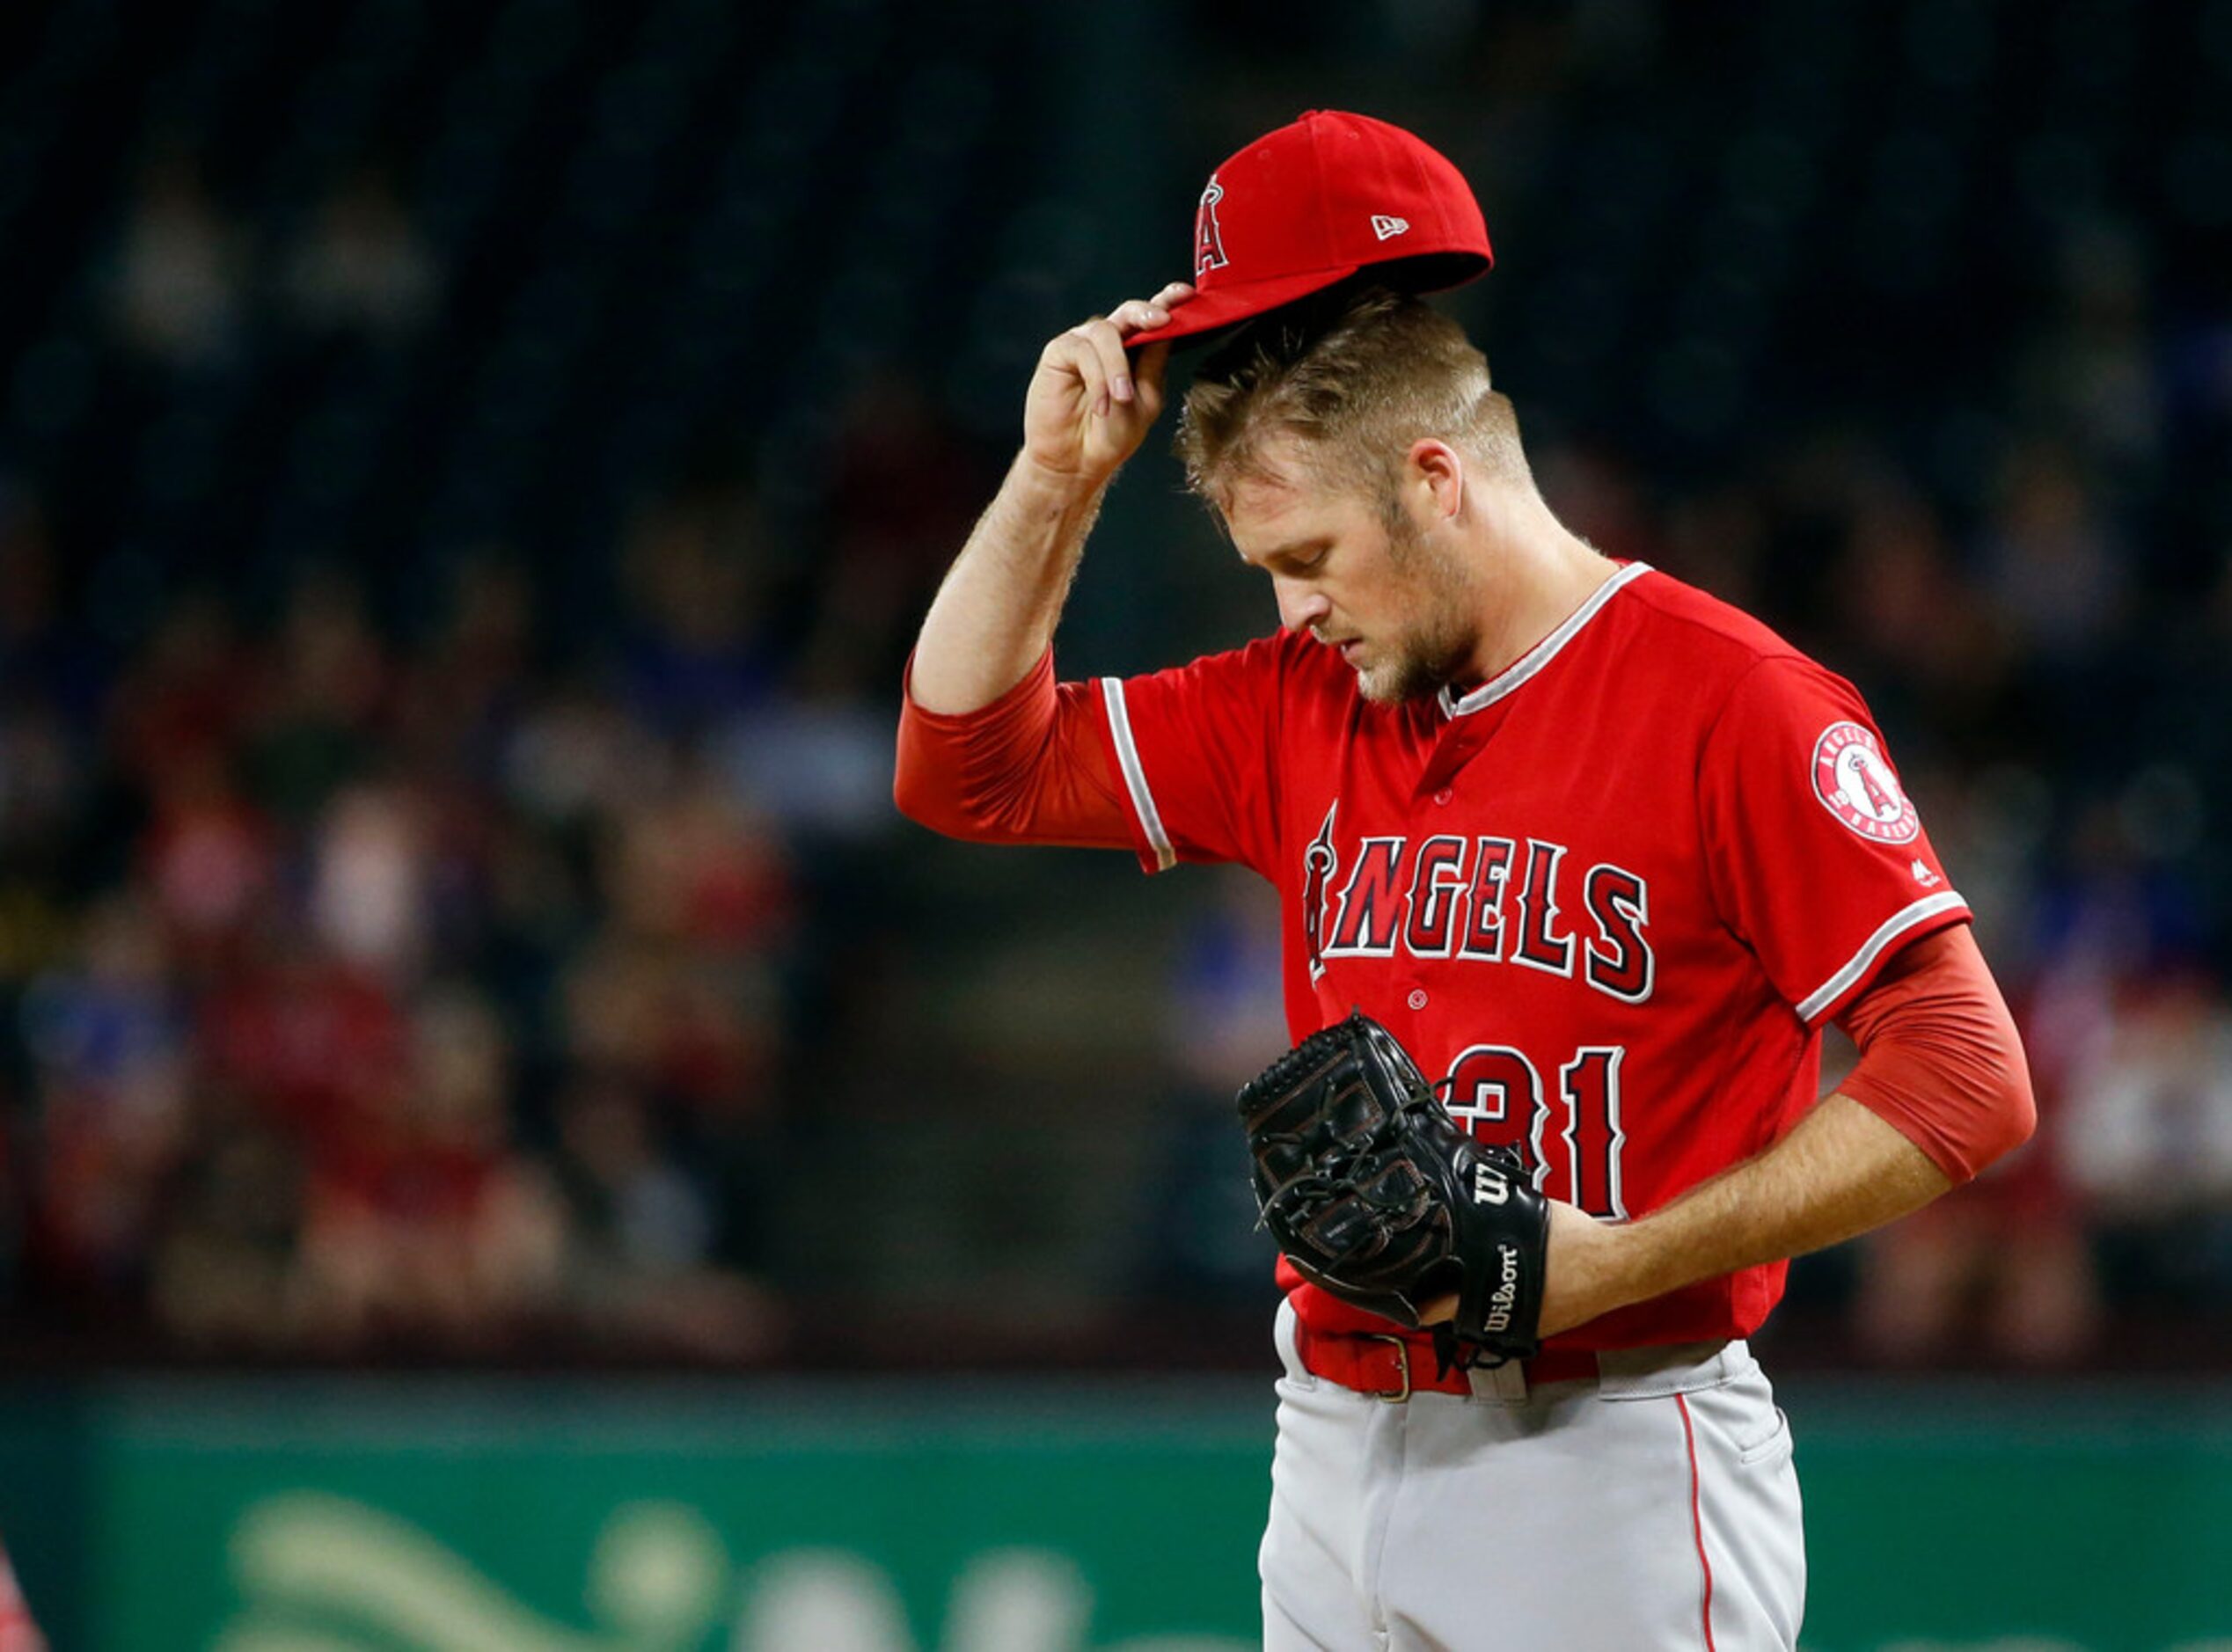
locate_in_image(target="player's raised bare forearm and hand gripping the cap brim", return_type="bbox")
[909,281,1194,714]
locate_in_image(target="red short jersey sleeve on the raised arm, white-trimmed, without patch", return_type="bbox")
[1096,639,1288,875]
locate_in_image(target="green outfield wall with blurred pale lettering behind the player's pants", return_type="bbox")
[0,1379,2232,1652]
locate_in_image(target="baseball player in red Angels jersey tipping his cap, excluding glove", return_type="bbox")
[897,113,2033,1652]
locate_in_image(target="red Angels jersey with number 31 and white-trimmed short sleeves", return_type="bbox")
[1101,563,1969,1349]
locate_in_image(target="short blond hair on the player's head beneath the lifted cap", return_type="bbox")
[1176,286,1531,526]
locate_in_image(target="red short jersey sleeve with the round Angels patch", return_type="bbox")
[1699,654,1969,1022]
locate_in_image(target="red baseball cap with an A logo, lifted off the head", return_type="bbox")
[1125,109,1496,346]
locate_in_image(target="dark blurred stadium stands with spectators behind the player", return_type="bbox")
[0,0,2232,1364]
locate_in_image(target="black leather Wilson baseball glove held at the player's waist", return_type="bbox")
[1239,1009,1549,1360]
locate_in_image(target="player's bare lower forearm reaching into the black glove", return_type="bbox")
[1542,1096,1953,1335]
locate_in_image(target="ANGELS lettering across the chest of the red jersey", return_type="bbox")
[1301,801,1658,1005]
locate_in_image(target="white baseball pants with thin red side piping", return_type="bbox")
[1259,1306,1805,1652]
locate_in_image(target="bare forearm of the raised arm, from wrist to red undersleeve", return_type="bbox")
[909,456,1107,717]
